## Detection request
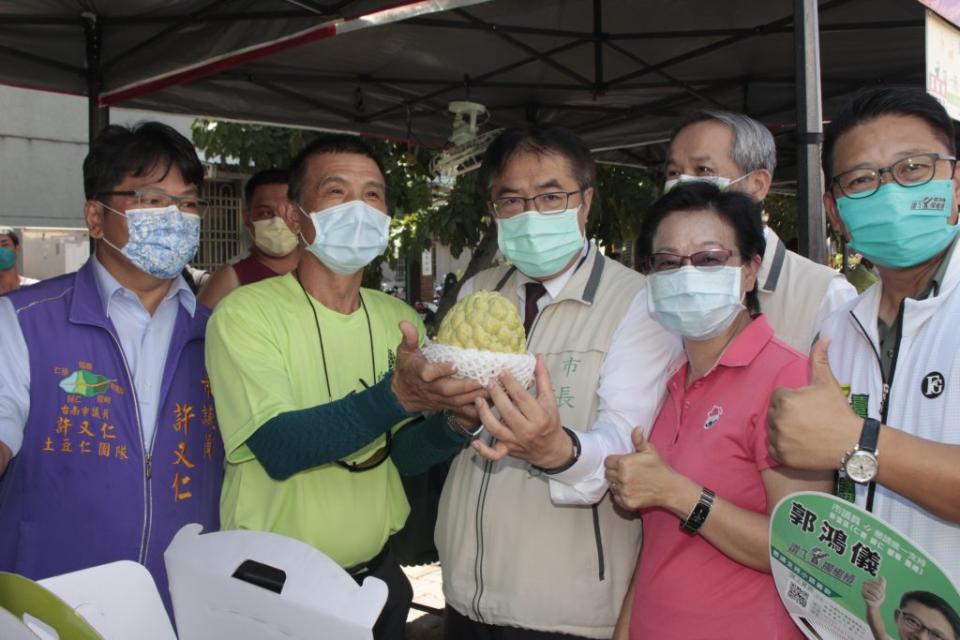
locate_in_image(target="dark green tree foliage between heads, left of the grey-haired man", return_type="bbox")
[193,119,660,321]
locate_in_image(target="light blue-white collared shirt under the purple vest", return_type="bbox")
[0,256,197,455]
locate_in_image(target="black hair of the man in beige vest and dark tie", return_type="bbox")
[479,124,597,195]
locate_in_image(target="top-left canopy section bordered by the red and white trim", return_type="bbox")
[0,0,484,140]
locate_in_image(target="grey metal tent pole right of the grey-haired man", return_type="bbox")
[793,0,827,264]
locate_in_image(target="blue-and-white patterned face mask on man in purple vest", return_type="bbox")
[100,202,200,280]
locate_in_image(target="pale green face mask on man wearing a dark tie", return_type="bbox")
[497,207,583,278]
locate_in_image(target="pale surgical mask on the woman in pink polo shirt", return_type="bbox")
[647,265,744,340]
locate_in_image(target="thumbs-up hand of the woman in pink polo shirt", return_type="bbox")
[603,427,696,510]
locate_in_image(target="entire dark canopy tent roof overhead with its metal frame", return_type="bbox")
[0,0,956,257]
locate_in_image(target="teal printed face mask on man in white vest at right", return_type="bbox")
[837,178,957,269]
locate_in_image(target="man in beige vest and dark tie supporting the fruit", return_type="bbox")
[436,126,680,640]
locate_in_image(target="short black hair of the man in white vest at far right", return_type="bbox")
[823,87,957,181]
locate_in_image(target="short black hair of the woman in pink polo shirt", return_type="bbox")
[637,181,766,314]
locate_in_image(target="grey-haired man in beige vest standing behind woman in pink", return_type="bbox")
[664,110,857,353]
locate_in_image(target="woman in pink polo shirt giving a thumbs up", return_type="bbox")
[605,182,830,640]
